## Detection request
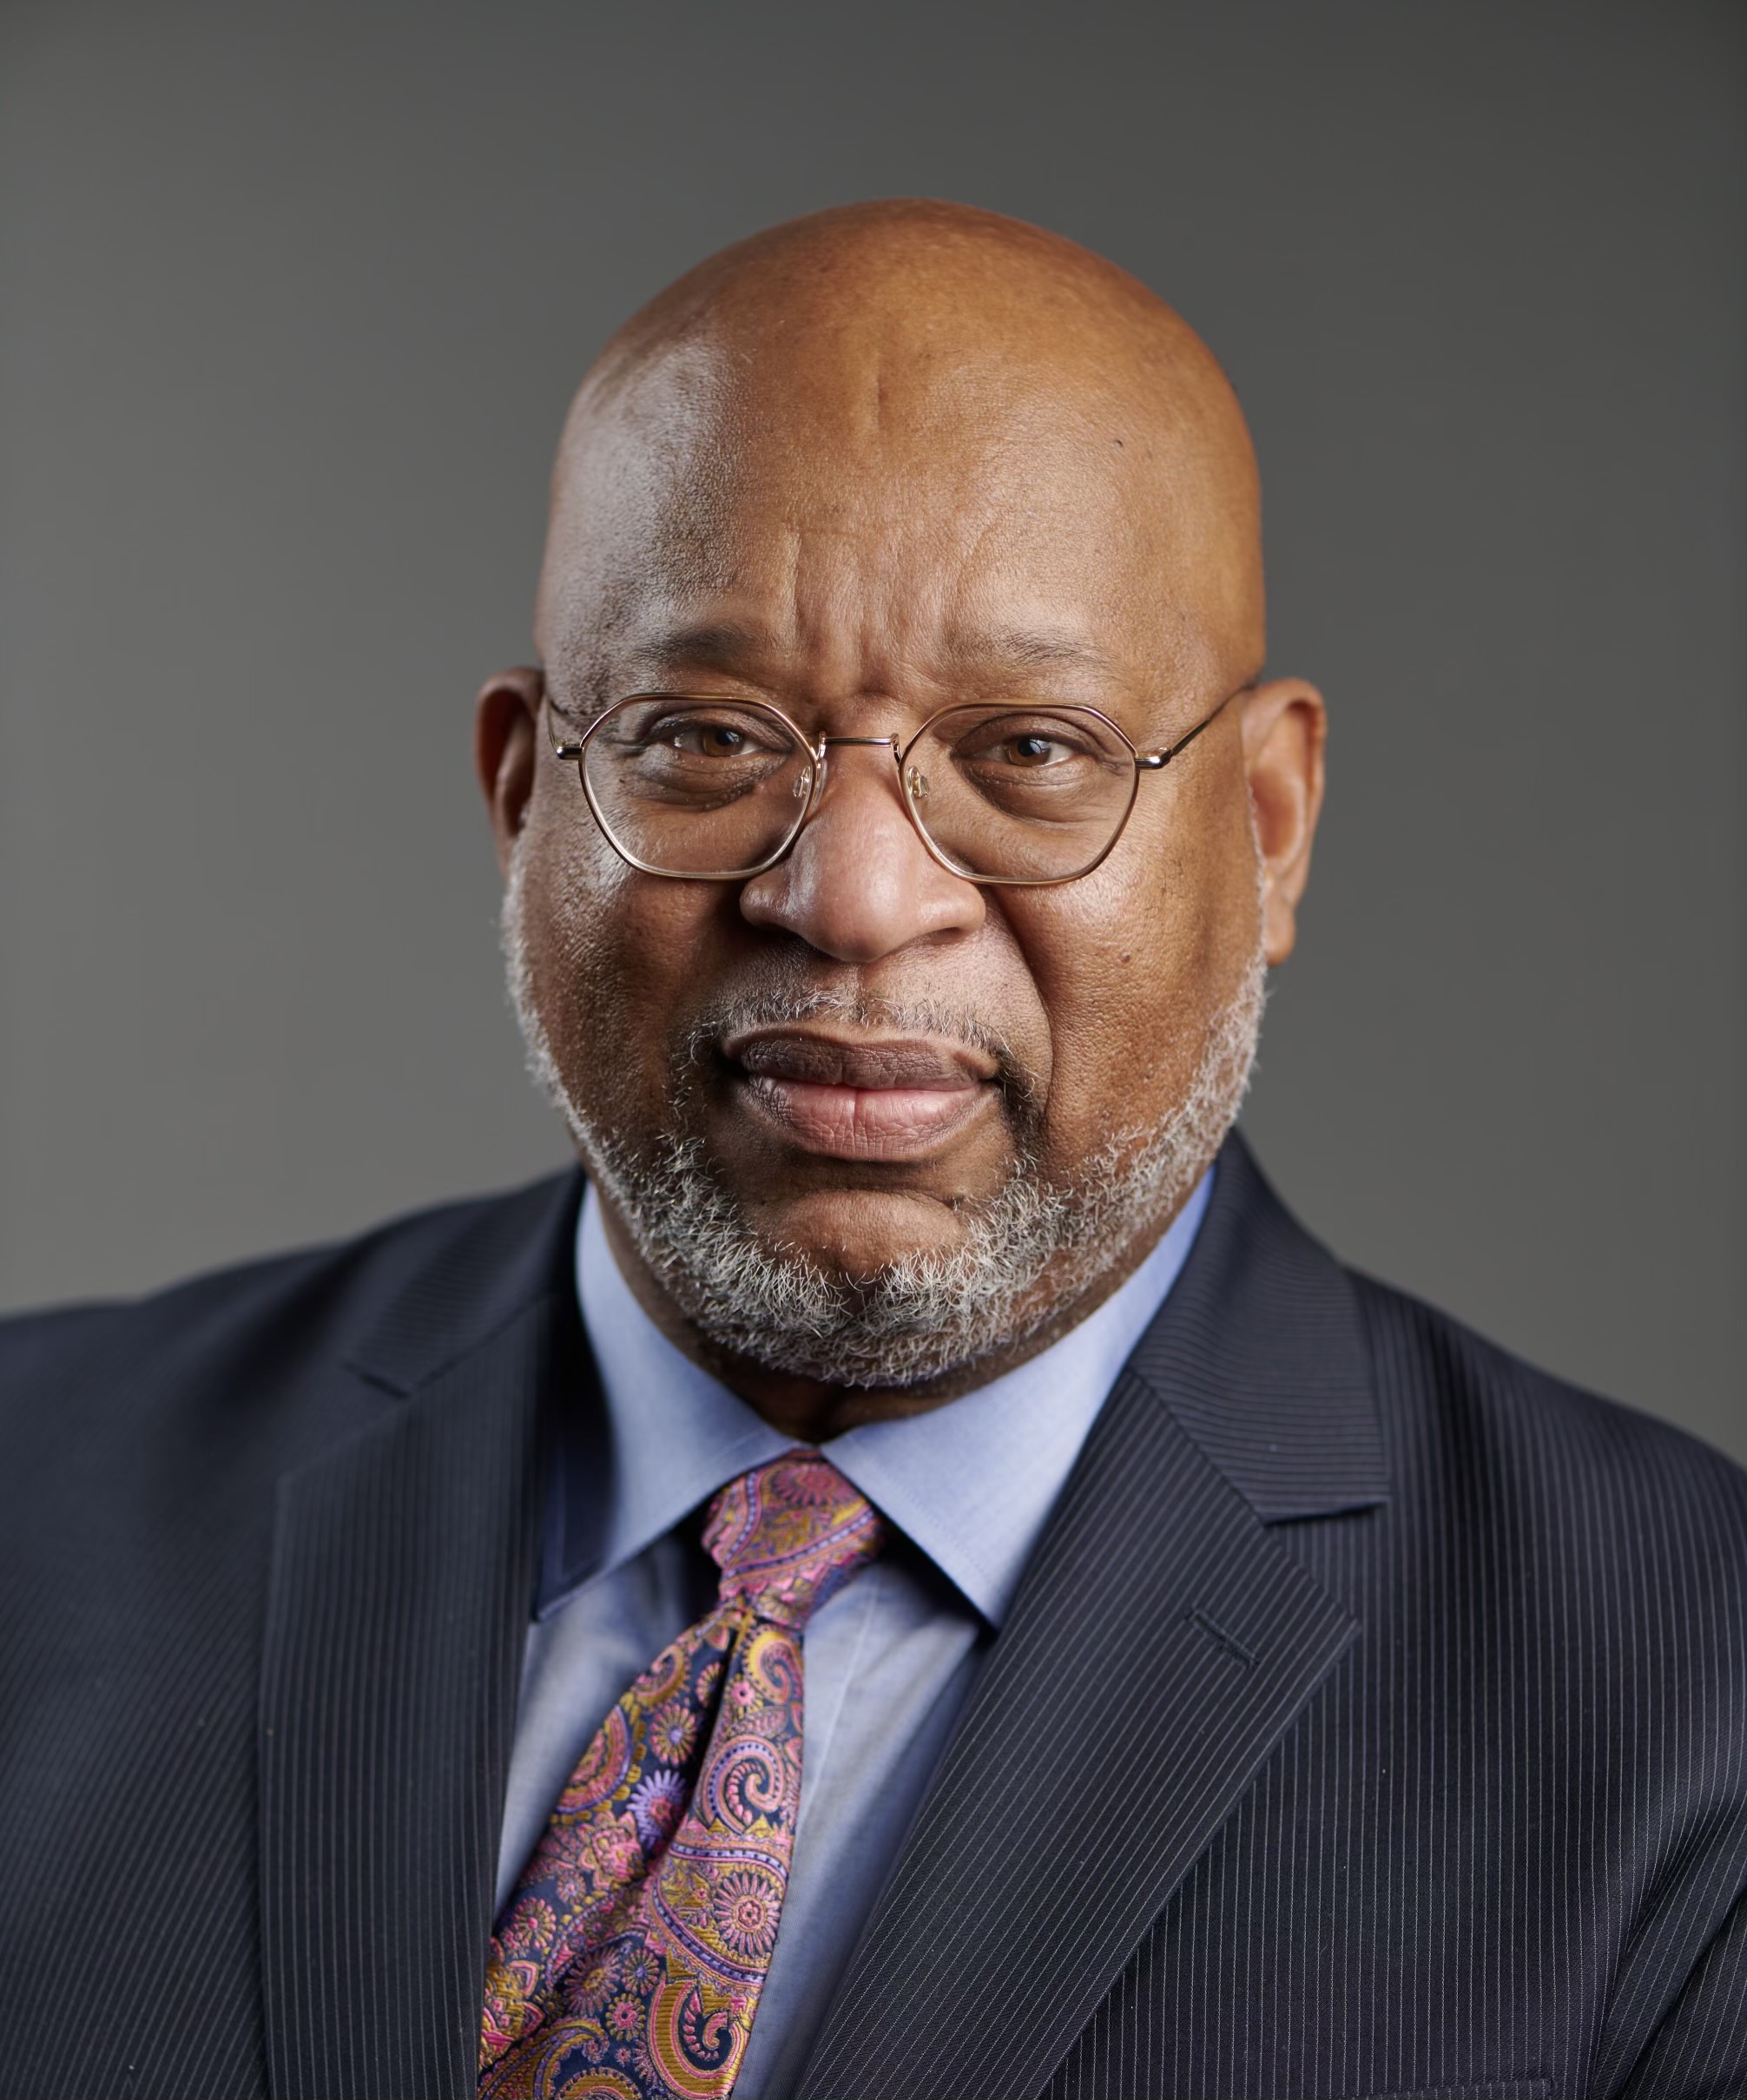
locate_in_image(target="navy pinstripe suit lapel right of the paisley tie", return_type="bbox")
[800,1141,1386,2100]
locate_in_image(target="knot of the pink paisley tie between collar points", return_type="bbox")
[703,1452,887,1632]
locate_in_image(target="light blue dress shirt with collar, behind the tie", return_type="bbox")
[498,1169,1211,2100]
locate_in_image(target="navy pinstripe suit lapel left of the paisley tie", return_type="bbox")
[260,1184,579,2100]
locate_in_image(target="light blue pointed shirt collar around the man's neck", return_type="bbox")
[537,1168,1214,1625]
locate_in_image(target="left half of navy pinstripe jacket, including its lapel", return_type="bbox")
[0,1180,570,2100]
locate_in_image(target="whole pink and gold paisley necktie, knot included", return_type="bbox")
[478,1452,884,2100]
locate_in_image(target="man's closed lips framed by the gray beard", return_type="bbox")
[722,1027,999,1162]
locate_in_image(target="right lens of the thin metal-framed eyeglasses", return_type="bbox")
[903,701,1134,882]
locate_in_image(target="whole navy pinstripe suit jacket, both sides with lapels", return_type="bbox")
[0,1141,1747,2100]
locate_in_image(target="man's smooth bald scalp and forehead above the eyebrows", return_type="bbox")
[537,200,1264,697]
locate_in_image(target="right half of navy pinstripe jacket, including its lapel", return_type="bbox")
[804,1147,1747,2100]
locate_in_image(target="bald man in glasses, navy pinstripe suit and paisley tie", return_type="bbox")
[0,204,1747,2100]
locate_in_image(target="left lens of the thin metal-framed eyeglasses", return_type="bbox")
[582,695,813,876]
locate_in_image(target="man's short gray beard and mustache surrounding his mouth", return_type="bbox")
[502,857,1266,1388]
